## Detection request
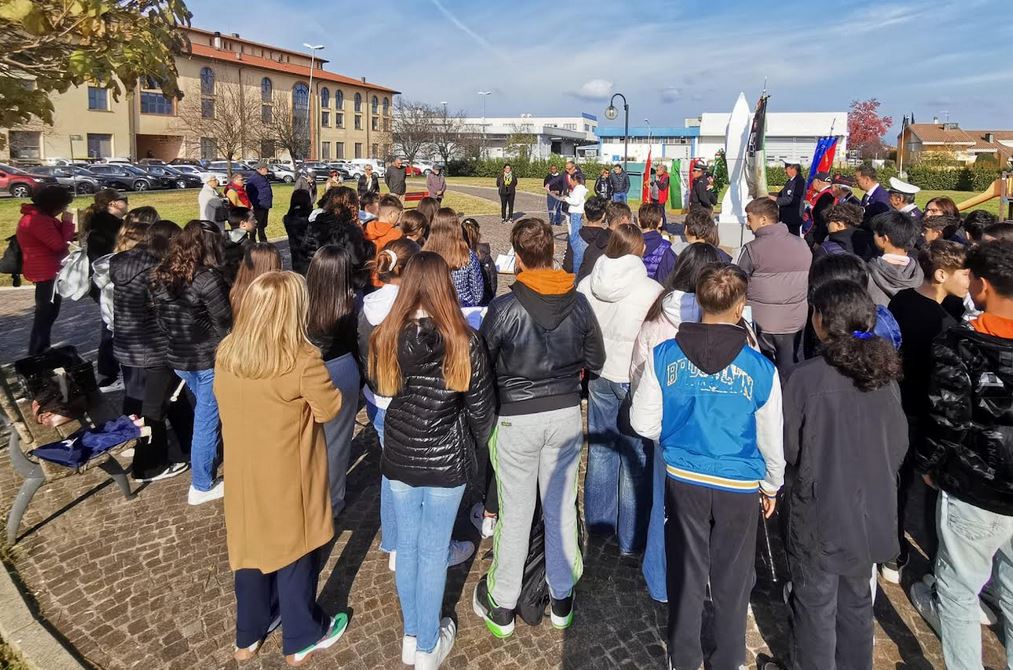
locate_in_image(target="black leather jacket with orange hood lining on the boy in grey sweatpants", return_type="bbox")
[481,275,605,416]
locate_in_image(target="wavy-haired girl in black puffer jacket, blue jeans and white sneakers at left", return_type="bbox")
[149,219,232,505]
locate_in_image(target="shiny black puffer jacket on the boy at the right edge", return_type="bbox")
[916,324,1013,516]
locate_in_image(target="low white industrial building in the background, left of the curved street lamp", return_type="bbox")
[462,113,598,158]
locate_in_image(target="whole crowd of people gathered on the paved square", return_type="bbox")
[17,163,1013,670]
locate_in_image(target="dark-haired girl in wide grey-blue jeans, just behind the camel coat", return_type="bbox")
[306,244,362,517]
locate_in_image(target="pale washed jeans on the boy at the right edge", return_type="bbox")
[936,492,1013,670]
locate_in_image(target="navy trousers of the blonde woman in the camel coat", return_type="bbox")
[235,549,330,656]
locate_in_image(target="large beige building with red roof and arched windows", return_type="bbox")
[3,28,398,162]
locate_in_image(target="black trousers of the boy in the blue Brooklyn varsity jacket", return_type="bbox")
[665,477,757,670]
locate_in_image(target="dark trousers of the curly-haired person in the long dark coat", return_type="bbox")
[788,556,873,670]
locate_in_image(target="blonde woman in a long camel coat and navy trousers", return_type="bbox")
[215,272,355,665]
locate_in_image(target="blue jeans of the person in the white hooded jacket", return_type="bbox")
[583,377,652,553]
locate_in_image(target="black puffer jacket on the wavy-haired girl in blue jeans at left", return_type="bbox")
[151,268,232,370]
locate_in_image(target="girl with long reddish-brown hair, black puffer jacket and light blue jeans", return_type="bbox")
[368,251,495,668]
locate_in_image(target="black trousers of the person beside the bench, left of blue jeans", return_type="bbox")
[123,365,193,479]
